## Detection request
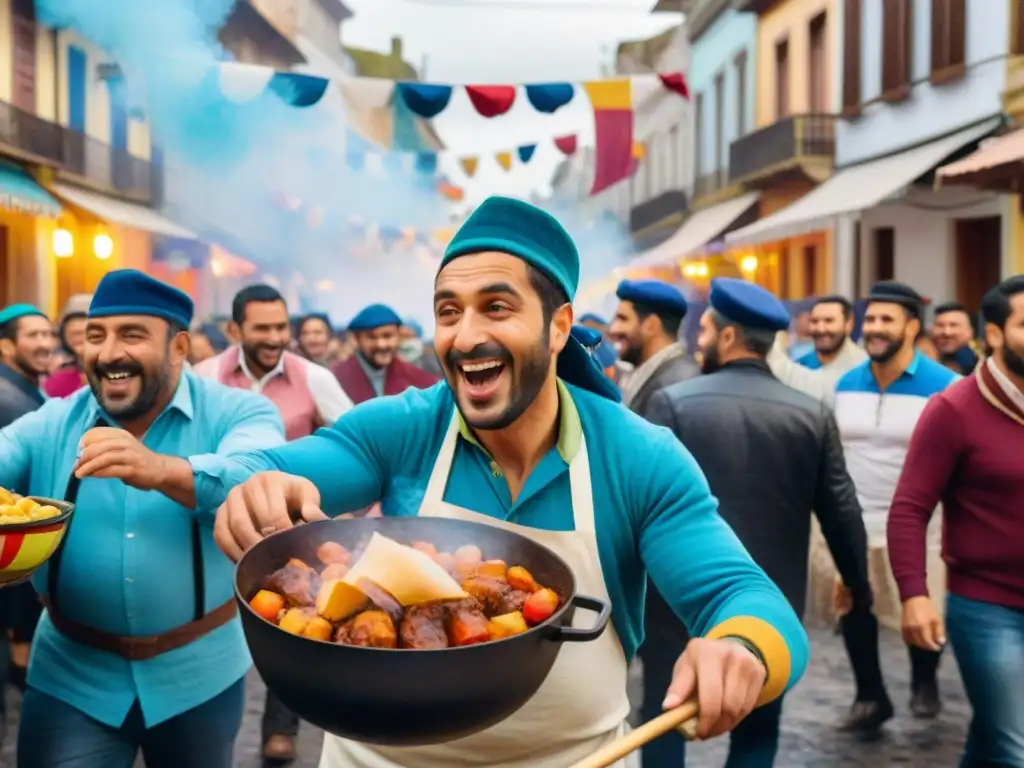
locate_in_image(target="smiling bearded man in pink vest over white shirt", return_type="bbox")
[196,285,352,440]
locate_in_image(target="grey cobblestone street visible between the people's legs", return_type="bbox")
[0,629,969,768]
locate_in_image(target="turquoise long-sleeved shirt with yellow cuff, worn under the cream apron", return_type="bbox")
[220,382,809,695]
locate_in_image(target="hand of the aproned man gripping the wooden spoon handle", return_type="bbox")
[664,637,767,738]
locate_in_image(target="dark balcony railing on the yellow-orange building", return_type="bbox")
[729,115,836,182]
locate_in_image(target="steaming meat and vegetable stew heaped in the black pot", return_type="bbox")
[249,532,561,650]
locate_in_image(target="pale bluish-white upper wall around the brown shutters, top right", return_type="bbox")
[834,0,1011,166]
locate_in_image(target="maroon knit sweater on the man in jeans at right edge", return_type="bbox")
[888,367,1024,608]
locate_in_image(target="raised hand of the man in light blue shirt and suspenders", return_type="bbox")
[75,427,167,490]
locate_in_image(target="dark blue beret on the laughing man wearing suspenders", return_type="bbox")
[89,269,194,328]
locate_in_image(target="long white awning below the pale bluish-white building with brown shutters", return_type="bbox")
[725,118,1001,245]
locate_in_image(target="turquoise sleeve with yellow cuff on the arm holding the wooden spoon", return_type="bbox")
[637,432,810,703]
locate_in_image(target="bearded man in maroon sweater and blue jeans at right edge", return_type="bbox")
[888,275,1024,766]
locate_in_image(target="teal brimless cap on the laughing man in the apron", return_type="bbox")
[440,197,580,301]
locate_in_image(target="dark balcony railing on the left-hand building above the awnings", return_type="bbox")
[0,101,156,202]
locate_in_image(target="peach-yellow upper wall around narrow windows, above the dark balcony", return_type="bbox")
[756,0,840,128]
